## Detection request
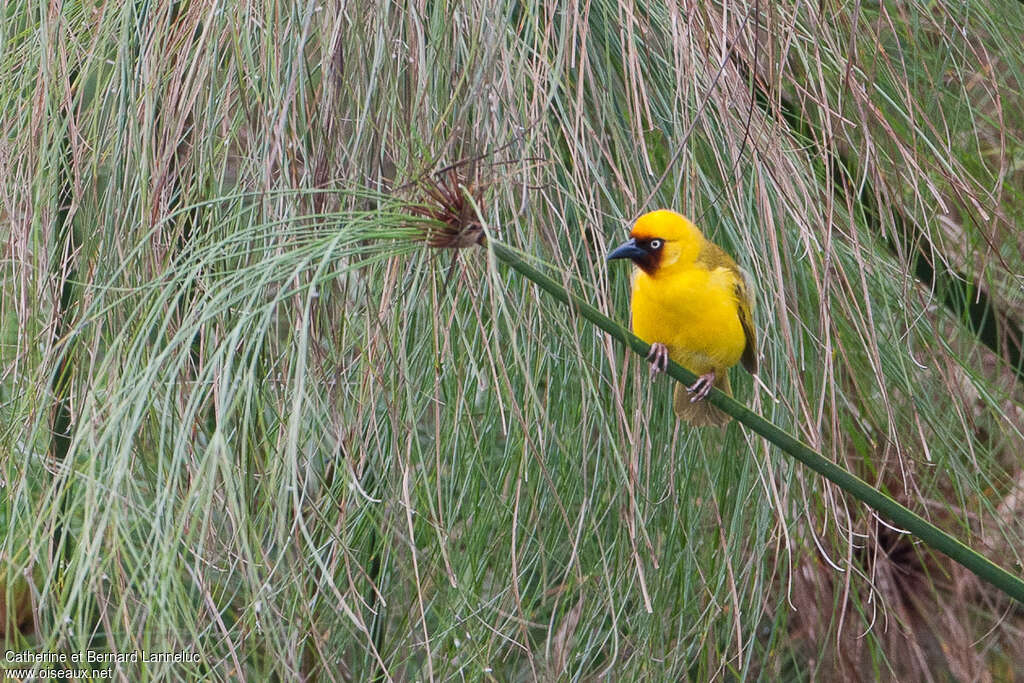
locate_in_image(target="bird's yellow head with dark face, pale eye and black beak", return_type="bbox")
[608,209,705,276]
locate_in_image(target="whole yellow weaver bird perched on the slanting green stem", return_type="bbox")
[608,209,758,426]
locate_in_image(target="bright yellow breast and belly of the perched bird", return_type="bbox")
[633,267,746,375]
